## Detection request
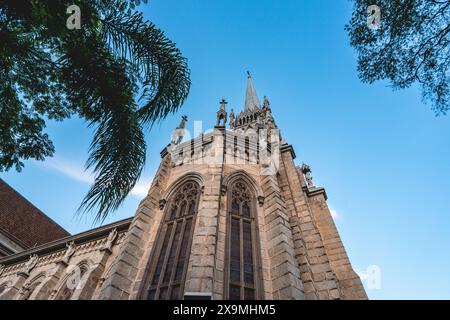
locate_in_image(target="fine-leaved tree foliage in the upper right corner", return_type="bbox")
[346,0,450,115]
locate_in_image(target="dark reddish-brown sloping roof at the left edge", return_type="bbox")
[0,179,70,248]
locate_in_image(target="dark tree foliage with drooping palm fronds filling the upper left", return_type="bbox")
[0,0,190,220]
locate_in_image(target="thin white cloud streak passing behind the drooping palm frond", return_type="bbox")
[44,158,152,198]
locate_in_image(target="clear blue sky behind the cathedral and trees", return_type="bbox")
[1,0,450,299]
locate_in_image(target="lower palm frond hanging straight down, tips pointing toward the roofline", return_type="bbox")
[79,108,146,222]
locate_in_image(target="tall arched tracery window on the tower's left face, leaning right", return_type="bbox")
[148,181,200,300]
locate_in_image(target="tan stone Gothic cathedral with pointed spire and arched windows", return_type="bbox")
[0,74,367,300]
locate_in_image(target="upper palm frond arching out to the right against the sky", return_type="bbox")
[102,5,191,125]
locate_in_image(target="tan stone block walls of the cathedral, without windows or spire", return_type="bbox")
[0,131,367,300]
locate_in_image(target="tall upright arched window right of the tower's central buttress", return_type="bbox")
[225,180,259,300]
